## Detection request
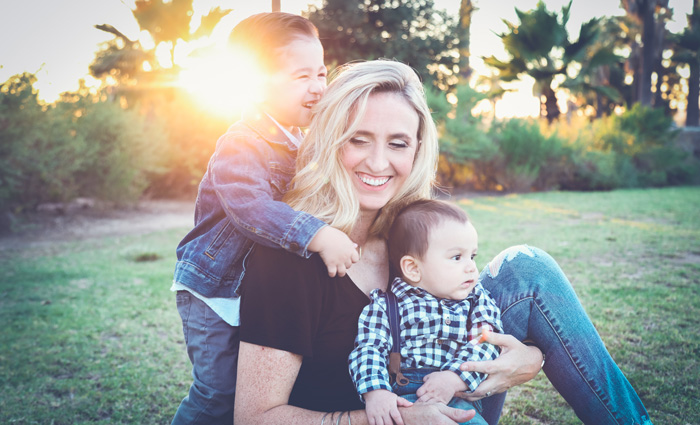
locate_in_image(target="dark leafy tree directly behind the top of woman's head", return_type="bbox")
[307,0,460,89]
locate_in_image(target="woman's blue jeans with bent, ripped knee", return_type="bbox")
[481,246,651,425]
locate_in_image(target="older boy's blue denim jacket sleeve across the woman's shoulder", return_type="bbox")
[209,133,326,257]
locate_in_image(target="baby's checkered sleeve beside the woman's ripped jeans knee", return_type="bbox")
[442,284,503,392]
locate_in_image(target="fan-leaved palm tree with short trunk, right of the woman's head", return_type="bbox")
[484,0,610,122]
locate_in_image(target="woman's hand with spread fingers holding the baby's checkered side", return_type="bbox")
[455,332,542,401]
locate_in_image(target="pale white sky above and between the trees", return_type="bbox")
[0,0,692,115]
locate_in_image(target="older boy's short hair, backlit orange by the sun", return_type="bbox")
[228,12,318,71]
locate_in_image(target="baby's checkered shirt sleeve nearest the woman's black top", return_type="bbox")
[348,290,392,398]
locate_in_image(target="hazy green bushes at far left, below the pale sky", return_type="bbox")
[0,74,165,215]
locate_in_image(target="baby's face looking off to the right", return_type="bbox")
[404,219,479,300]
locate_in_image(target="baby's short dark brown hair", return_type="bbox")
[388,199,469,276]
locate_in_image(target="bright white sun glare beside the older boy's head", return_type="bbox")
[178,48,263,117]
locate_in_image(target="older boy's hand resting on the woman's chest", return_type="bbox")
[309,226,360,277]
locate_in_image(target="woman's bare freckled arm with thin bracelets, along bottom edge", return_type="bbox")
[234,342,474,425]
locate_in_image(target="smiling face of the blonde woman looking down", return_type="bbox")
[340,93,419,213]
